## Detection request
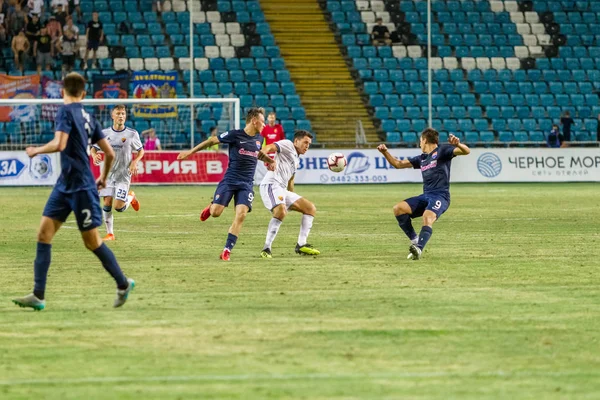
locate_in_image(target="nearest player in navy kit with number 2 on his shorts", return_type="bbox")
[13,73,135,310]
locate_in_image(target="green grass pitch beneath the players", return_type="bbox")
[0,184,600,400]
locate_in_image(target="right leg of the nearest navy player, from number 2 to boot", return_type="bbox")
[72,191,135,307]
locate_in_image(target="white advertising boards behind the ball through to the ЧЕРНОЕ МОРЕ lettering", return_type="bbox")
[295,148,600,184]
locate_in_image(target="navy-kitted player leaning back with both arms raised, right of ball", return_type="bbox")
[377,128,471,260]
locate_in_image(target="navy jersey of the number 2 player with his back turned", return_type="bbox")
[55,103,104,193]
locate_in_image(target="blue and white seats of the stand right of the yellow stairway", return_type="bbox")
[322,0,600,145]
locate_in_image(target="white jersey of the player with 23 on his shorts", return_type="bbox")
[94,127,143,182]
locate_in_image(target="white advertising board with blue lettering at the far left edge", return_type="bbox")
[0,151,60,186]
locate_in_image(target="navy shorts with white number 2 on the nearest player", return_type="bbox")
[42,188,102,232]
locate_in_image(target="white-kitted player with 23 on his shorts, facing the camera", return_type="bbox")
[92,104,144,240]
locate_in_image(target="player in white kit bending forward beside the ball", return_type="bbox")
[260,130,321,258]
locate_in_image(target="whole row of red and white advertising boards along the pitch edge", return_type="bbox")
[0,148,600,186]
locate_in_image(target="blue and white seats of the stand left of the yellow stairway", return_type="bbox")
[0,0,312,148]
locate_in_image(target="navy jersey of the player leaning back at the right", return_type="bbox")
[408,144,456,199]
